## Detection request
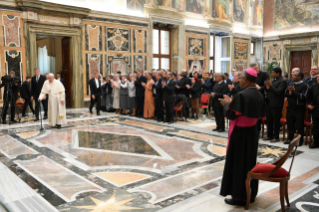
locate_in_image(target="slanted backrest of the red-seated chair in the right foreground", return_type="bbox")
[265,135,301,177]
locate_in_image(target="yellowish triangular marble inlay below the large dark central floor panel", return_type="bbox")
[94,172,151,187]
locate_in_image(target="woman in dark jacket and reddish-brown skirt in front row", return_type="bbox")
[186,77,201,119]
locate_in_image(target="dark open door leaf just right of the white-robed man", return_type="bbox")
[62,38,72,108]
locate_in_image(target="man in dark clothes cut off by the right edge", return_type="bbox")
[307,77,319,149]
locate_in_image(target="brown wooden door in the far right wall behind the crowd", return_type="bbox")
[290,51,311,78]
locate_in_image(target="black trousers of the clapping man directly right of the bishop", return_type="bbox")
[267,107,282,139]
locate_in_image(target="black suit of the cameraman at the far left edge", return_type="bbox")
[0,78,21,121]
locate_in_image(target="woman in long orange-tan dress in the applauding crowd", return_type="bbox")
[142,72,155,119]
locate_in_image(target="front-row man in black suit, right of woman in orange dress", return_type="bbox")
[162,72,176,124]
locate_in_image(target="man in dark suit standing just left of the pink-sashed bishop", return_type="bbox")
[211,73,229,132]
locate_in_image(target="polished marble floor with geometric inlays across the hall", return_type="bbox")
[0,109,319,212]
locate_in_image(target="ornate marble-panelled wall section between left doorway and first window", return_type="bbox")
[83,21,149,97]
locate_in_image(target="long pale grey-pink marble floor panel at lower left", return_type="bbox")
[15,156,104,202]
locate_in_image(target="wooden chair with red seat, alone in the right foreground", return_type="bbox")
[246,135,300,212]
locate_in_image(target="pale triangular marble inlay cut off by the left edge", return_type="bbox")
[0,135,38,158]
